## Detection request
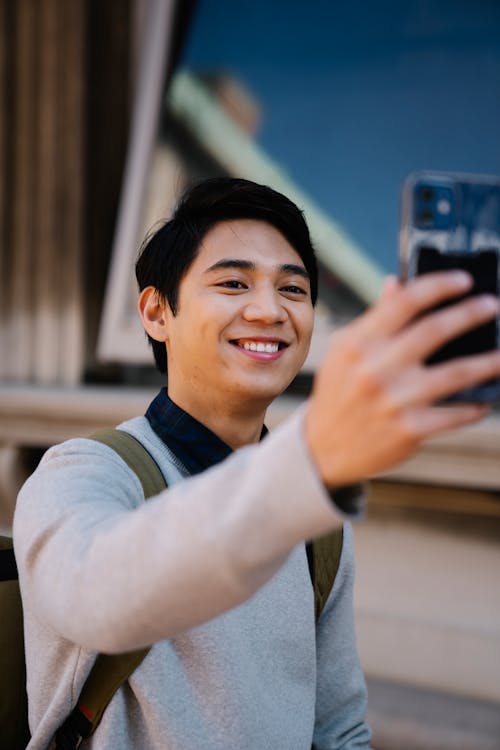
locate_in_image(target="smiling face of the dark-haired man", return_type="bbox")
[163,219,314,413]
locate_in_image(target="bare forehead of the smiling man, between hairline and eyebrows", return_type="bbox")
[193,219,304,270]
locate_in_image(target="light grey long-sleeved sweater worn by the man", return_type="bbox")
[14,413,370,750]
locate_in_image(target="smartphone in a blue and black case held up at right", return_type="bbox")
[399,172,500,402]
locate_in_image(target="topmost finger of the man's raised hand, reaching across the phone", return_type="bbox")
[356,271,473,341]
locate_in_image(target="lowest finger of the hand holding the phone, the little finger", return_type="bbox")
[407,404,491,441]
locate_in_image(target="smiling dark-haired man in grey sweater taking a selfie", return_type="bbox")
[15,178,500,750]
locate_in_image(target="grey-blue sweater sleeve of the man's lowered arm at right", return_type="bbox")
[314,523,371,750]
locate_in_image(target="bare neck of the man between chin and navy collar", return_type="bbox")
[168,389,268,450]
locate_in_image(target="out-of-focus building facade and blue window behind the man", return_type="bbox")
[0,0,500,750]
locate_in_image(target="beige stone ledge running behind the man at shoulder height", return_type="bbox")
[0,383,500,490]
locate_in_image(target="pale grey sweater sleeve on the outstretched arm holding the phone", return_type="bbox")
[14,412,354,653]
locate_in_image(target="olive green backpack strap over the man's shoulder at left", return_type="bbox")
[56,429,167,750]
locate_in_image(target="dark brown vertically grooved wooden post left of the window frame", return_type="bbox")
[0,0,131,386]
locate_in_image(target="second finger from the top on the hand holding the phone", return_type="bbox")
[376,295,500,368]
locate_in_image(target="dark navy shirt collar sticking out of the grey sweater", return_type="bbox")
[146,388,267,475]
